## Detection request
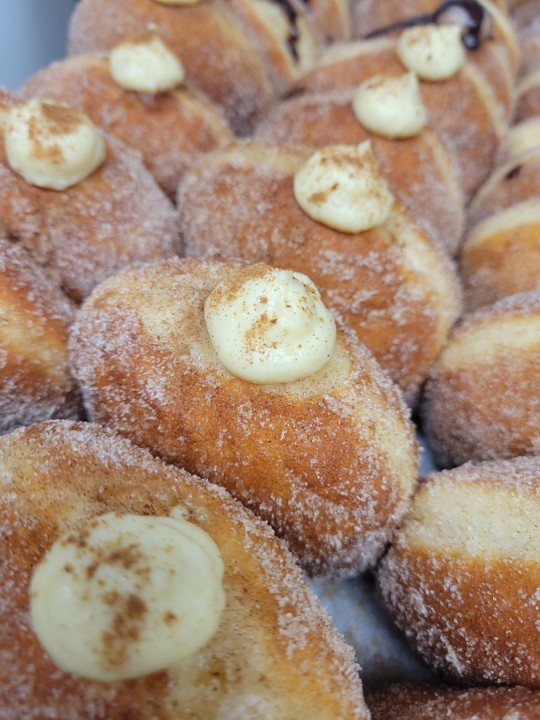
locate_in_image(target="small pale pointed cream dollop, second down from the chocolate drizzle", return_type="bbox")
[353,72,427,139]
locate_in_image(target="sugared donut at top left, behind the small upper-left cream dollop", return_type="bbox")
[68,0,275,134]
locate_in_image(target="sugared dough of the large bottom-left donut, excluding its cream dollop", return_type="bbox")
[0,421,368,720]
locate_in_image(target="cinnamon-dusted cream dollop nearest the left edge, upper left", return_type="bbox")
[4,98,106,190]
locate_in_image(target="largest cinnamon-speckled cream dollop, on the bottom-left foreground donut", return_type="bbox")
[30,512,225,682]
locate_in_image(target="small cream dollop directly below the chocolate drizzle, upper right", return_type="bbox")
[396,25,466,81]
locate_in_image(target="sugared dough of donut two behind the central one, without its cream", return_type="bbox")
[255,90,464,254]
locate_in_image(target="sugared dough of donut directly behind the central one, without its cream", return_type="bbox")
[178,142,461,404]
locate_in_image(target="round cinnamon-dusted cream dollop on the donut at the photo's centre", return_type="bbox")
[204,263,336,384]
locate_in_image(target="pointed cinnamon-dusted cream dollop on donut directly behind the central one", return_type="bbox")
[294,141,393,233]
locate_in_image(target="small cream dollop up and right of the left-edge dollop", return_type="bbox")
[109,29,185,94]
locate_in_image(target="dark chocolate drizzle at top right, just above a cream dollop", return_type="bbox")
[364,0,490,50]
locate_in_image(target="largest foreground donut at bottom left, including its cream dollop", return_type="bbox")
[0,420,368,720]
